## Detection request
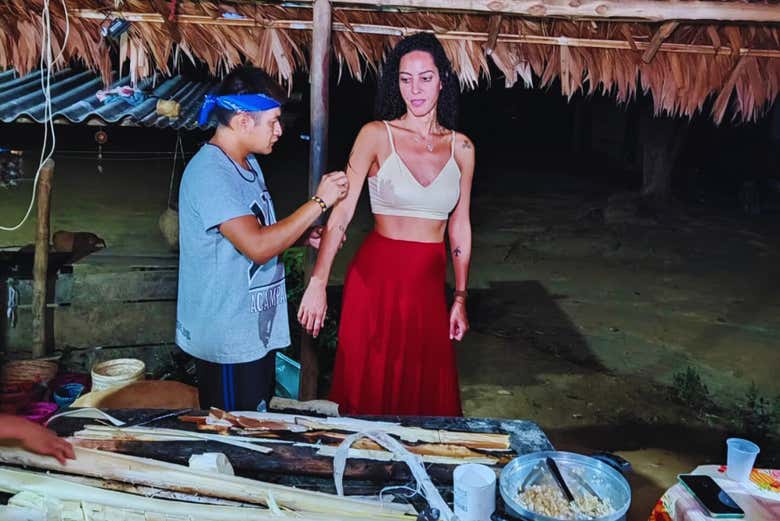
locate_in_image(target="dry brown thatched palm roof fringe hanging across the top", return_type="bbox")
[0,0,780,122]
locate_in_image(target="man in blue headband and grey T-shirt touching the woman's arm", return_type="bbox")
[176,67,348,410]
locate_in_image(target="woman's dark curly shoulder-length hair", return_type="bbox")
[374,33,460,130]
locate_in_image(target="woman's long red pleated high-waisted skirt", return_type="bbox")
[330,231,462,416]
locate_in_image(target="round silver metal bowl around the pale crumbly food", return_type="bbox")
[499,451,631,521]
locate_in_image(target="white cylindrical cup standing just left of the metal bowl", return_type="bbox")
[452,463,496,521]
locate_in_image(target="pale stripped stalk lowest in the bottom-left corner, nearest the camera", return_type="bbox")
[0,468,414,521]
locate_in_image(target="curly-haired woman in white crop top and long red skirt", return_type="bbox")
[298,34,474,416]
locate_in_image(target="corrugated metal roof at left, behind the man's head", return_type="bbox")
[0,69,216,129]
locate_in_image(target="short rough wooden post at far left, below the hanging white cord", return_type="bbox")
[32,159,54,358]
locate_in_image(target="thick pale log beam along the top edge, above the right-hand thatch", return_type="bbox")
[332,0,780,23]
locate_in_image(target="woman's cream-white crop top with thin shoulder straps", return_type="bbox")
[368,121,460,220]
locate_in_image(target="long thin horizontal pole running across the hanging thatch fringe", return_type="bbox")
[71,10,780,58]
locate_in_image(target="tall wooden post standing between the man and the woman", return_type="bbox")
[298,0,332,400]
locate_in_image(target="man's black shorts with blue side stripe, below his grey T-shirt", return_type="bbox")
[195,351,276,411]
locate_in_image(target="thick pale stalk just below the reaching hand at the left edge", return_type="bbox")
[0,447,411,519]
